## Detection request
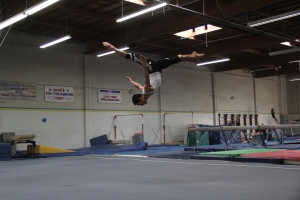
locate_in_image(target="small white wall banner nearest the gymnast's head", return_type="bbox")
[98,89,122,103]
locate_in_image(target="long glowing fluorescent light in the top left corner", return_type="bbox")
[0,0,59,30]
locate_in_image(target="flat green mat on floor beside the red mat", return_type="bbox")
[199,148,283,157]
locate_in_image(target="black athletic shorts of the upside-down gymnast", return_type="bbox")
[126,53,180,74]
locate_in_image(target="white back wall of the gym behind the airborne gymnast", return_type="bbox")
[0,34,287,149]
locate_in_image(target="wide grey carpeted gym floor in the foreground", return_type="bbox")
[0,155,300,200]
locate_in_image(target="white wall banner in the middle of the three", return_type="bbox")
[45,85,74,102]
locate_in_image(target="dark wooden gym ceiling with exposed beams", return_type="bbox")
[0,0,300,78]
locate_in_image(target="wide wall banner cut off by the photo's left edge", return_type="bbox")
[0,80,36,101]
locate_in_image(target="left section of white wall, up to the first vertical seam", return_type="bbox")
[0,34,84,148]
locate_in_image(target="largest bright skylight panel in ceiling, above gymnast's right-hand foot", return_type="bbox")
[174,24,222,40]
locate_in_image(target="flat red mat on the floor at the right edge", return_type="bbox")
[240,150,300,161]
